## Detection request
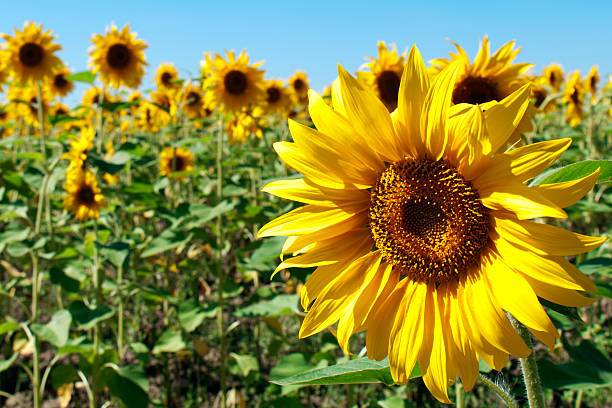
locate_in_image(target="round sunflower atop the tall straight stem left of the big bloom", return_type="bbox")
[204,51,264,111]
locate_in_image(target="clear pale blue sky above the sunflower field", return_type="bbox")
[0,0,612,102]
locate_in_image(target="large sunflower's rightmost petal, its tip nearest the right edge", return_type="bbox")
[495,217,606,256]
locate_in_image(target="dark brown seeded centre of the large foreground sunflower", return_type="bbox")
[369,159,490,283]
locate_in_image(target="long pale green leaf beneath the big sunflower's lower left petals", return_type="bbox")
[270,357,421,385]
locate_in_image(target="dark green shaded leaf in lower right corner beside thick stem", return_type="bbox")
[538,340,612,390]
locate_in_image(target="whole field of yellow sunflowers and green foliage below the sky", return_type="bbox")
[0,22,612,408]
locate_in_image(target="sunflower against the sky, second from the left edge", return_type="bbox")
[89,24,148,88]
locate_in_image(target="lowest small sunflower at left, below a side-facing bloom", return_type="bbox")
[63,170,106,221]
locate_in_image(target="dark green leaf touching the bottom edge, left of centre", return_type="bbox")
[103,365,150,408]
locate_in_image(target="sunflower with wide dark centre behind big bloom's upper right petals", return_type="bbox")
[429,36,537,144]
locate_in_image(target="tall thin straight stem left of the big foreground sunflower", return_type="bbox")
[217,117,227,408]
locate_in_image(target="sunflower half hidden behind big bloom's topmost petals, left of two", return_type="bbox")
[357,41,406,112]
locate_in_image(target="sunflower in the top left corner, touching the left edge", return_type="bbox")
[2,21,62,84]
